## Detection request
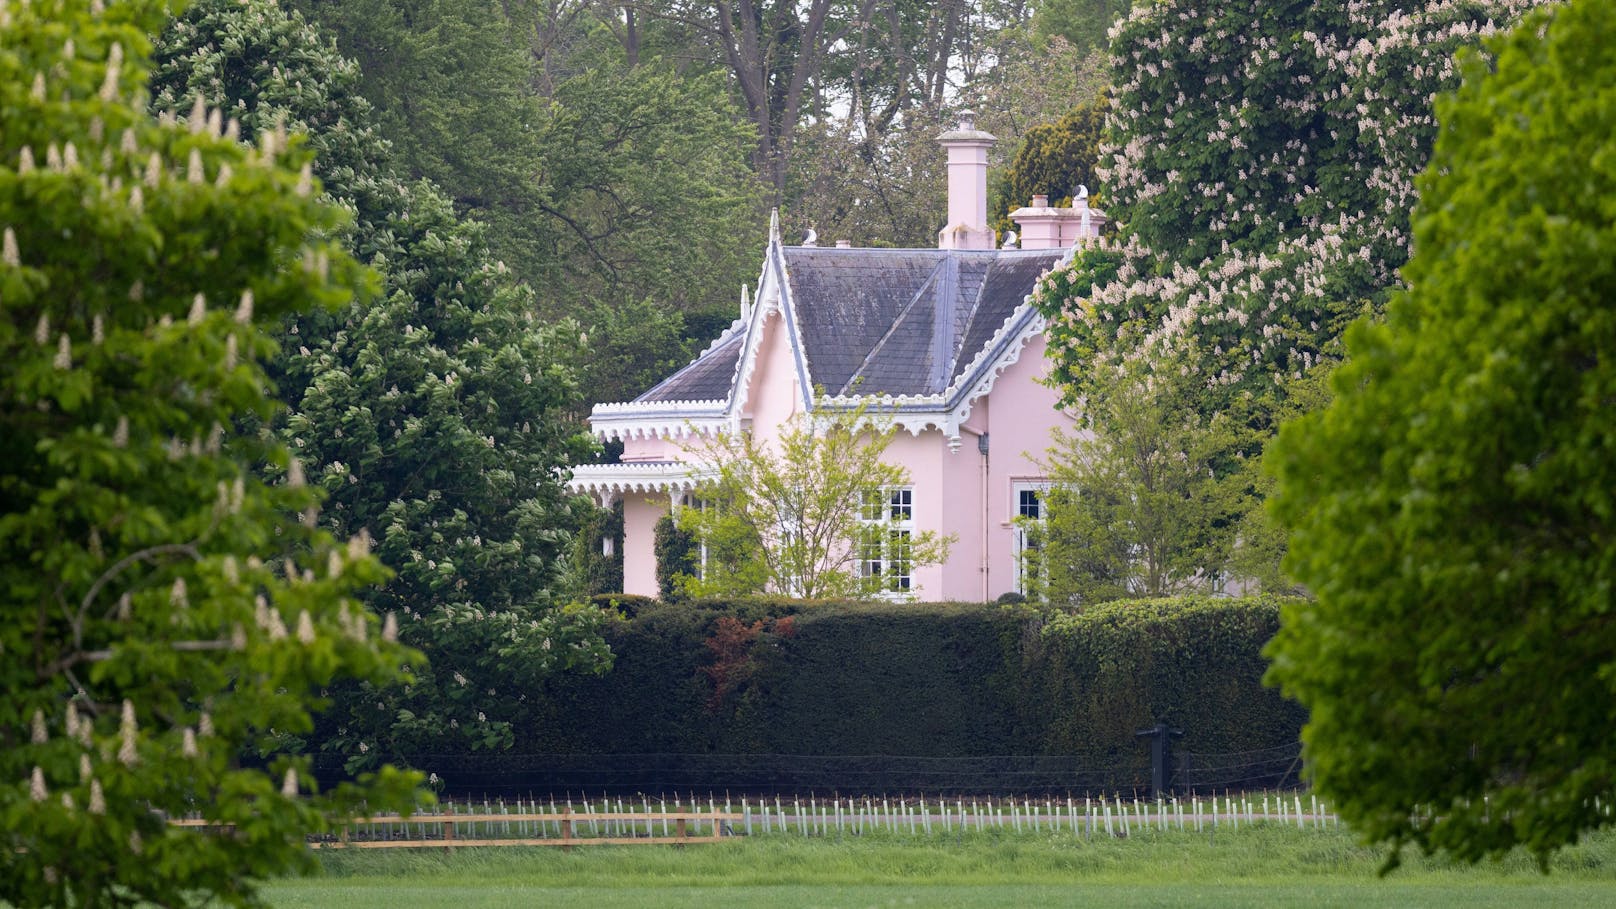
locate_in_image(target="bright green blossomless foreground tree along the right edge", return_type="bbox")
[1270,0,1616,864]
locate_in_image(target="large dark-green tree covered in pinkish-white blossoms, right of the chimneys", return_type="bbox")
[1037,0,1535,408]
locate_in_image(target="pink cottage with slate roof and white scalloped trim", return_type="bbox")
[570,112,1105,602]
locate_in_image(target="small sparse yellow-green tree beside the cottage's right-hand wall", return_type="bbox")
[1028,359,1251,603]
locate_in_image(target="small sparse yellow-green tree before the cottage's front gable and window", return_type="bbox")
[679,408,953,598]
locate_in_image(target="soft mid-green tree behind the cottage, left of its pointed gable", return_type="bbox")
[297,0,766,320]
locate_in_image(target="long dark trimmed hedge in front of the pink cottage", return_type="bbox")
[514,597,1306,760]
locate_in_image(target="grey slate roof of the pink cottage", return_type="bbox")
[637,246,1065,403]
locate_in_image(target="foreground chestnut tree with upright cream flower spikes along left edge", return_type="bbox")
[0,0,414,906]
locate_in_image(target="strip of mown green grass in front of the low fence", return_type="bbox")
[267,825,1616,909]
